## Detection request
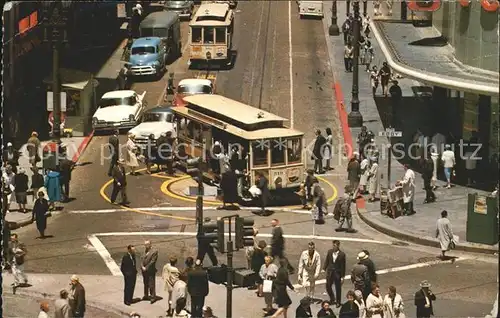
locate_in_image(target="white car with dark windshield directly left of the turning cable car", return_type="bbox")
[129,106,176,148]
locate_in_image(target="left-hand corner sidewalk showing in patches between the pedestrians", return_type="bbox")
[5,134,93,230]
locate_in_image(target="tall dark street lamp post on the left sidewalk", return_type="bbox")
[43,1,71,142]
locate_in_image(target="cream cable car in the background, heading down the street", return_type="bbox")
[189,3,234,65]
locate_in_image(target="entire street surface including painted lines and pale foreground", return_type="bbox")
[4,1,498,318]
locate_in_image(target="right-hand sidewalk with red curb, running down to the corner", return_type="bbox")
[323,3,498,253]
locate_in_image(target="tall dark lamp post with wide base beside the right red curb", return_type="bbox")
[347,0,363,127]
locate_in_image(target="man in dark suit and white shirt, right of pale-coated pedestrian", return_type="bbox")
[323,240,346,308]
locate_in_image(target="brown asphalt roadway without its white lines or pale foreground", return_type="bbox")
[6,1,498,316]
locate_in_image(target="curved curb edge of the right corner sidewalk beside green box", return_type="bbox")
[356,204,498,255]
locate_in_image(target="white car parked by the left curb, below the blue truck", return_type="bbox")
[92,90,146,131]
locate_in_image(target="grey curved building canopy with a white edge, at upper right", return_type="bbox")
[371,20,499,96]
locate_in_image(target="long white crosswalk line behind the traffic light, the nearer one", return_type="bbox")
[94,232,392,245]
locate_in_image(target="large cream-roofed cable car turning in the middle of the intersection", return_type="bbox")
[172,94,305,193]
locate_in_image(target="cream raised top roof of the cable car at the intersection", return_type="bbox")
[184,94,288,125]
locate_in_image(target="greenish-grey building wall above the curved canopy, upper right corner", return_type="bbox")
[432,1,499,72]
